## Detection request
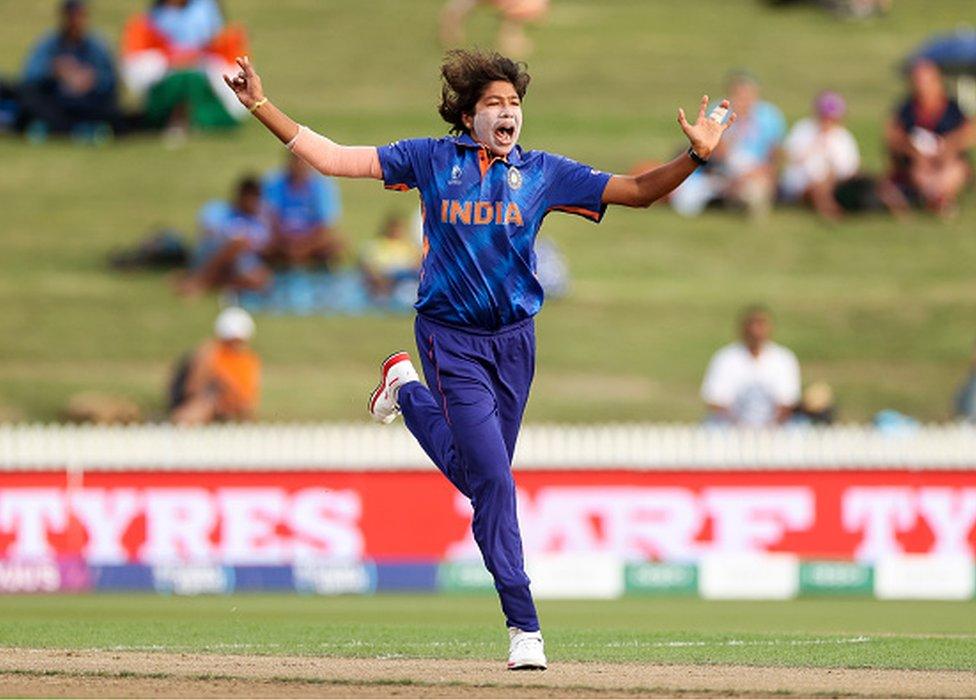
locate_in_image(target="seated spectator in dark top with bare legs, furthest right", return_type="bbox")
[885,59,973,216]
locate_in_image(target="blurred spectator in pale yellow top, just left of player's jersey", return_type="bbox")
[360,214,421,301]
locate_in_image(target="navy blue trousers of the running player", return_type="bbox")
[399,316,539,632]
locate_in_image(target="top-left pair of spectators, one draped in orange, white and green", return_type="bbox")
[0,0,247,142]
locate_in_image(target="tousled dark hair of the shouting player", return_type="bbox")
[437,49,531,134]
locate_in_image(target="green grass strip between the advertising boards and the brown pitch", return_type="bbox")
[0,595,976,671]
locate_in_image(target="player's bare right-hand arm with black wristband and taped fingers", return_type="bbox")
[603,95,736,207]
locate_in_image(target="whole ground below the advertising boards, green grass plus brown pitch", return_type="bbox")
[0,595,976,697]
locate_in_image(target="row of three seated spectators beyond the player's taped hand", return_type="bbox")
[671,65,976,221]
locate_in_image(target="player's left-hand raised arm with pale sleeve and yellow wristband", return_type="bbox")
[224,56,383,180]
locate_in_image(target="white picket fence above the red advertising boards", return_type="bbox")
[0,424,976,472]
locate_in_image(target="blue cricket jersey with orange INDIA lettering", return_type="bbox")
[377,134,611,330]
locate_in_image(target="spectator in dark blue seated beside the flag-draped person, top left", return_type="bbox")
[20,0,121,135]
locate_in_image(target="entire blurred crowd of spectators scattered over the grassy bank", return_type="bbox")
[0,0,976,426]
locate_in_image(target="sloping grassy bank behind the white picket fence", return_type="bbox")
[0,0,976,421]
